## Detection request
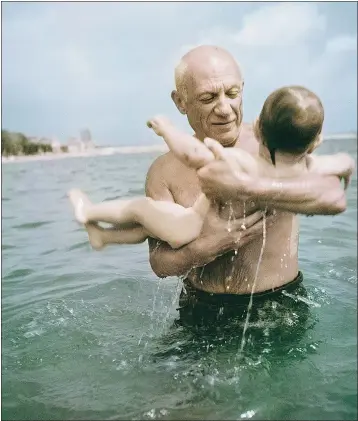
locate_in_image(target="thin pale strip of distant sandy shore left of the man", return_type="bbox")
[1,143,168,164]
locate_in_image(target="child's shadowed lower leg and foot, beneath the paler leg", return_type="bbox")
[85,222,149,250]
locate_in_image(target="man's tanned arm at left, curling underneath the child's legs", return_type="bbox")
[146,155,262,277]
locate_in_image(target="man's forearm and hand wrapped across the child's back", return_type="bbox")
[198,161,346,215]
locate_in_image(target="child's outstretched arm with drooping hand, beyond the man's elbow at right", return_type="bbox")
[307,152,355,189]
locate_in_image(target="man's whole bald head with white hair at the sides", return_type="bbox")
[171,45,243,146]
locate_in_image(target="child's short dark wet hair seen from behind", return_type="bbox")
[258,86,324,165]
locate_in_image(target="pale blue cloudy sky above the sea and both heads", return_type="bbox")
[2,2,357,145]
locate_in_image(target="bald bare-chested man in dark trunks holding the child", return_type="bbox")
[146,46,346,324]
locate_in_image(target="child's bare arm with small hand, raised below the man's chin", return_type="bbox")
[147,116,215,169]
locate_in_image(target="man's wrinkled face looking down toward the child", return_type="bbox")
[185,61,243,146]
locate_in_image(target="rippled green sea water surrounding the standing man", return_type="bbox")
[2,139,357,420]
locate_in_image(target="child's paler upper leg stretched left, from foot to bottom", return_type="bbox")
[69,190,204,248]
